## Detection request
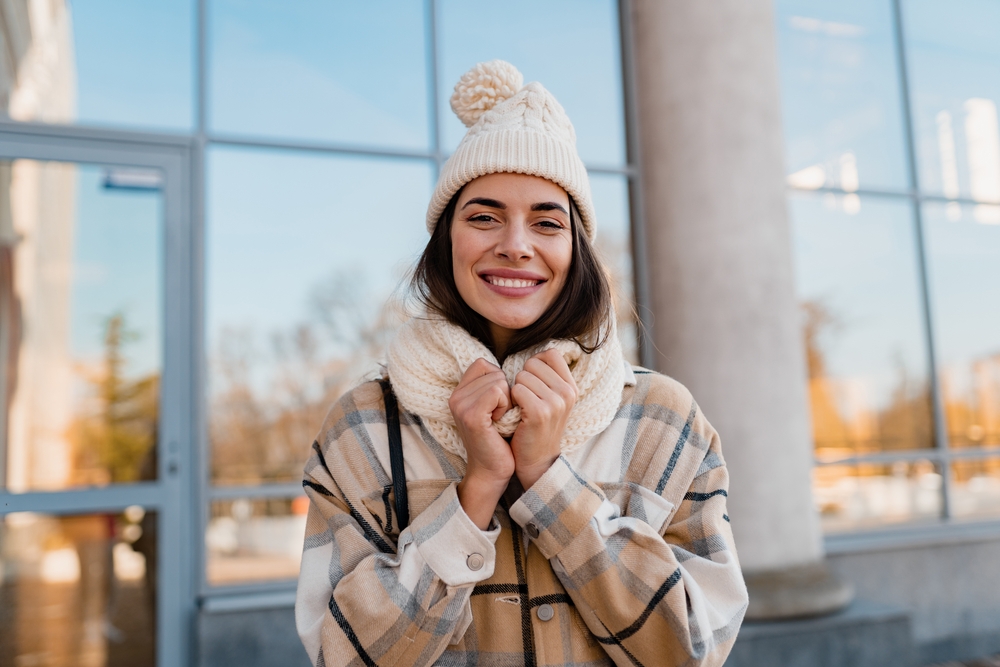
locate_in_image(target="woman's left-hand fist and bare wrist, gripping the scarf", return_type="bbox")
[448,359,514,530]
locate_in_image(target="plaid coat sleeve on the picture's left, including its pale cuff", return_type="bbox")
[295,429,500,667]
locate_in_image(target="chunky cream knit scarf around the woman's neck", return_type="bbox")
[388,315,625,459]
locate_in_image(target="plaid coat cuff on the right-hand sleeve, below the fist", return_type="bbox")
[510,456,605,559]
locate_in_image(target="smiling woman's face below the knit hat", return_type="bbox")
[451,174,573,351]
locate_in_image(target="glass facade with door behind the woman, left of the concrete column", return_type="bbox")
[0,5,639,652]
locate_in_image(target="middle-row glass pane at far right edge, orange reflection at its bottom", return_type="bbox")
[923,202,1000,447]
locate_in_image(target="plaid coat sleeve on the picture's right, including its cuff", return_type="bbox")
[510,414,747,667]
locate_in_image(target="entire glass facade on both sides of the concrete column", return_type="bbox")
[0,0,1000,665]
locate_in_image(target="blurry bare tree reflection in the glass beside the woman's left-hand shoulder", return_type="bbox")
[209,272,405,484]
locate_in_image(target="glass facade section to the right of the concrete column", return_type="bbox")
[776,0,1000,533]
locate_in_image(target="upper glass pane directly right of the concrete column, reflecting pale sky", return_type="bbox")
[775,0,908,192]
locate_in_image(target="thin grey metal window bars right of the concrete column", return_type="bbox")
[784,0,1000,554]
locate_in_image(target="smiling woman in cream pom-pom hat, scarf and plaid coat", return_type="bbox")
[296,61,747,667]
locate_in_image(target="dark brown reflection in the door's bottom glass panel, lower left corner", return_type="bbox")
[0,506,156,667]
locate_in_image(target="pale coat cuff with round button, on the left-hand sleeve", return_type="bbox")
[407,484,500,586]
